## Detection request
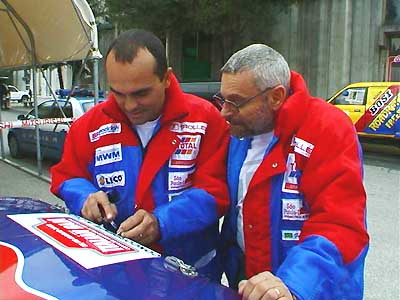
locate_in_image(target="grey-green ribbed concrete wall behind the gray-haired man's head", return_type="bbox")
[266,0,387,98]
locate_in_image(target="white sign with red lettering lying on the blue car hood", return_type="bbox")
[8,213,160,269]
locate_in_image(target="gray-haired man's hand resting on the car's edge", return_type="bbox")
[239,272,293,300]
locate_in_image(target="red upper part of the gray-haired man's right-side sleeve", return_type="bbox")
[300,105,369,263]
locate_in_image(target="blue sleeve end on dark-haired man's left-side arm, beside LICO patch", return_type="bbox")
[59,178,98,216]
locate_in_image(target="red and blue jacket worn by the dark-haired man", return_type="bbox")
[51,75,229,278]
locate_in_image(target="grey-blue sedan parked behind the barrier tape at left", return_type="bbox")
[7,98,102,161]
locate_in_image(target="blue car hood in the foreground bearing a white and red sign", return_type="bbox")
[0,197,241,300]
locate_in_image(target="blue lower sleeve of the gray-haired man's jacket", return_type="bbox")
[276,236,368,300]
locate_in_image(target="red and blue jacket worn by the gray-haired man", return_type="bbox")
[222,72,369,300]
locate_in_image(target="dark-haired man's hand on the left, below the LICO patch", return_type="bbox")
[81,191,117,223]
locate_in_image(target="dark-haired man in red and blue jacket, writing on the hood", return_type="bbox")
[51,30,229,278]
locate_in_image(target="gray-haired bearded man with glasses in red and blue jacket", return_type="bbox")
[214,44,369,300]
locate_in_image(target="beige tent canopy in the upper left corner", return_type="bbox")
[0,0,101,69]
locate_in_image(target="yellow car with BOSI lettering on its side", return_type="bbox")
[328,82,400,141]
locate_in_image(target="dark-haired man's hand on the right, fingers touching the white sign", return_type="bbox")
[117,209,161,246]
